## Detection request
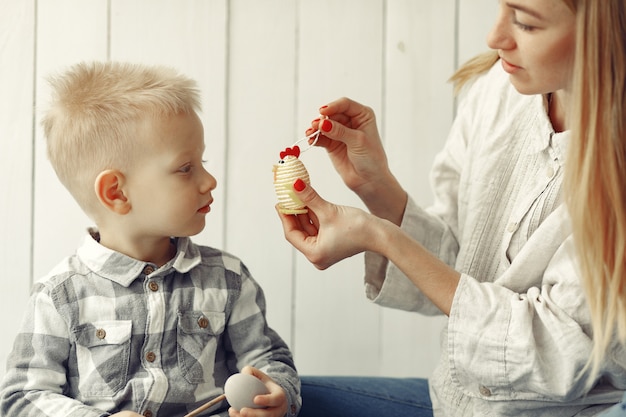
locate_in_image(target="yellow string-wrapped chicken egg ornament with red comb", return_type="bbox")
[273,146,311,214]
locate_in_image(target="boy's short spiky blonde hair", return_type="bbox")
[42,62,200,216]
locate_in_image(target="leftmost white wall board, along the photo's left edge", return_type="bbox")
[0,0,35,378]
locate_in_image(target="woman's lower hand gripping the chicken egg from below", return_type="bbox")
[278,180,381,269]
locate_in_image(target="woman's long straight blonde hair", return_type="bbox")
[450,0,626,377]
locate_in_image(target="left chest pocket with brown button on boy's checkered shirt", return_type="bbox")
[74,320,132,397]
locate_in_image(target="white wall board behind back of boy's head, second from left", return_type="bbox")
[33,0,107,279]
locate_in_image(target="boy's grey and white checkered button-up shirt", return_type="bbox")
[0,232,301,417]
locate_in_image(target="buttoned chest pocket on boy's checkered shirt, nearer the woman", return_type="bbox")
[177,311,226,384]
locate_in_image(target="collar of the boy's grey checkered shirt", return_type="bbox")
[76,229,201,287]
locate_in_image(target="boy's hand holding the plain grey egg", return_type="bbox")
[227,366,287,417]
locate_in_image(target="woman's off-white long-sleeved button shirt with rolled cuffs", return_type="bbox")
[365,64,626,417]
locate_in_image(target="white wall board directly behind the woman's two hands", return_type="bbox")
[295,0,384,375]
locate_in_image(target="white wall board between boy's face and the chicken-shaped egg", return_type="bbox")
[222,0,296,345]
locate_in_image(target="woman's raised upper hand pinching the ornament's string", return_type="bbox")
[306,98,407,224]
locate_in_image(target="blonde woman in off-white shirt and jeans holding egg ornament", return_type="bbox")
[281,0,626,417]
